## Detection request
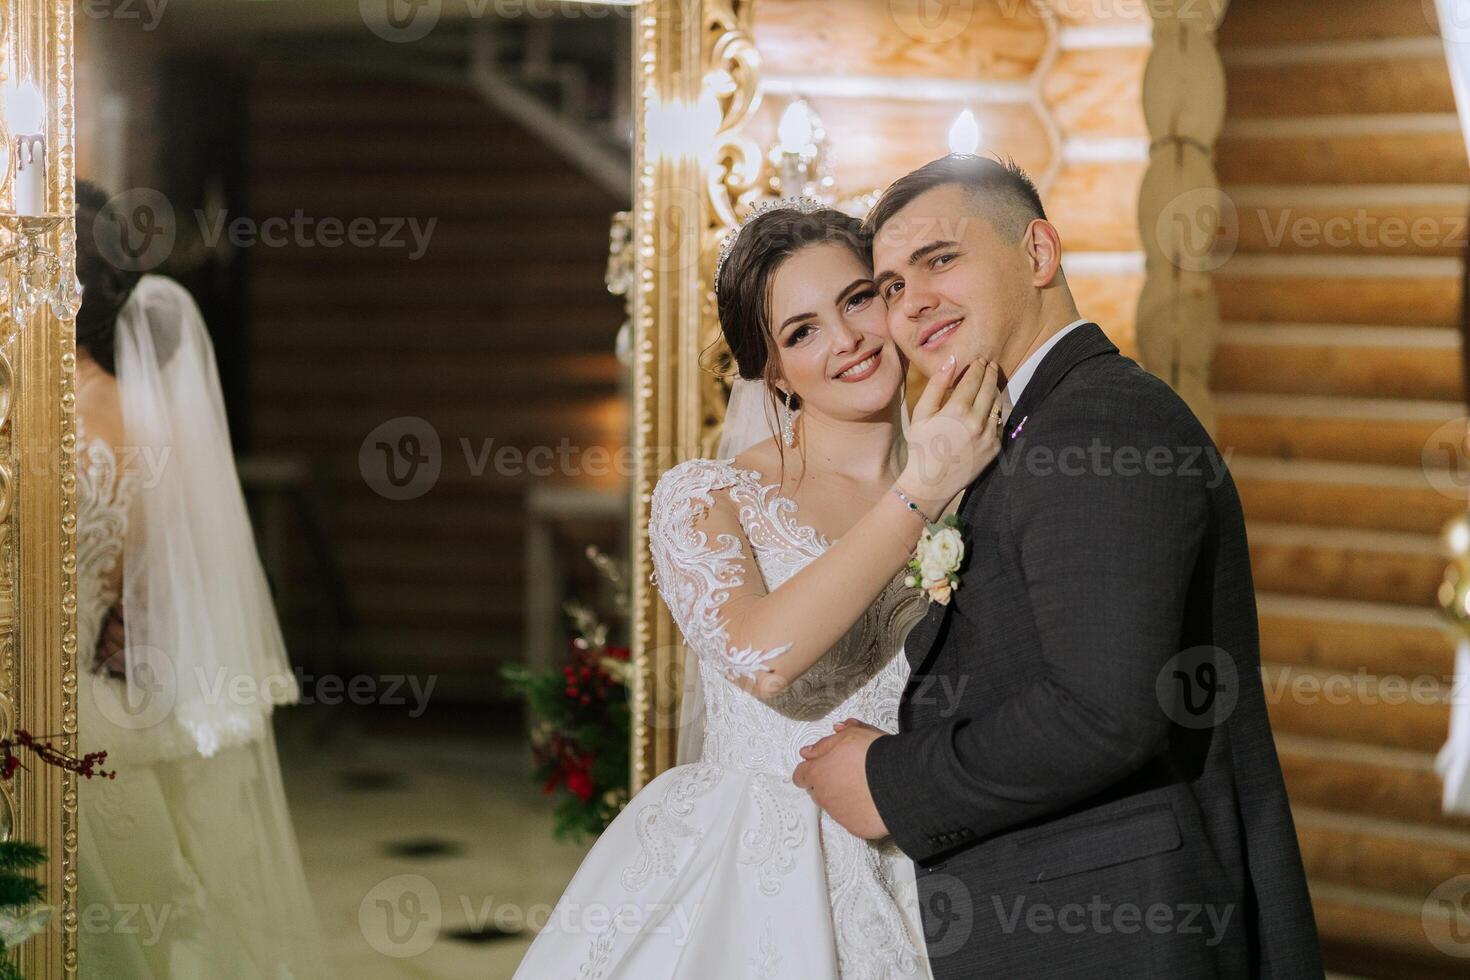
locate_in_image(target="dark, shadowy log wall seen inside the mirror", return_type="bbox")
[247,66,628,701]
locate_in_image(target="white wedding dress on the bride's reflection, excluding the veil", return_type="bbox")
[76,419,329,980]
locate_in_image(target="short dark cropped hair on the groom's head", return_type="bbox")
[863,153,1047,242]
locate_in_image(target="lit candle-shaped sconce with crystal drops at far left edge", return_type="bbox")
[0,79,82,339]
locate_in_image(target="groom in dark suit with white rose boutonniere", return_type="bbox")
[794,156,1322,980]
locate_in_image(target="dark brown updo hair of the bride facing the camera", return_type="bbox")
[716,207,873,467]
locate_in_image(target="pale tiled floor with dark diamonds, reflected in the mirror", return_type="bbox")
[278,708,585,980]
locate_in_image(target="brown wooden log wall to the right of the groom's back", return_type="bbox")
[1213,0,1470,980]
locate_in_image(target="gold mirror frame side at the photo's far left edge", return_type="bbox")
[0,0,78,977]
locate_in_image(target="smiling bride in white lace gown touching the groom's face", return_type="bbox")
[516,200,1000,980]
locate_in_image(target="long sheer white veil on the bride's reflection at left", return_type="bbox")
[115,275,297,757]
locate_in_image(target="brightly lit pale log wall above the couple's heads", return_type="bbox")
[747,0,1152,354]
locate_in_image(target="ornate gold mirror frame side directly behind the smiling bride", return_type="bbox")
[629,0,760,792]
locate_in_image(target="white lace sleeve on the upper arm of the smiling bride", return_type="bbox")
[648,460,791,677]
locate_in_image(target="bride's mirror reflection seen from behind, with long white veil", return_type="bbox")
[76,184,328,980]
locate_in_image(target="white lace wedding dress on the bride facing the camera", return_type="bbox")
[516,460,929,980]
